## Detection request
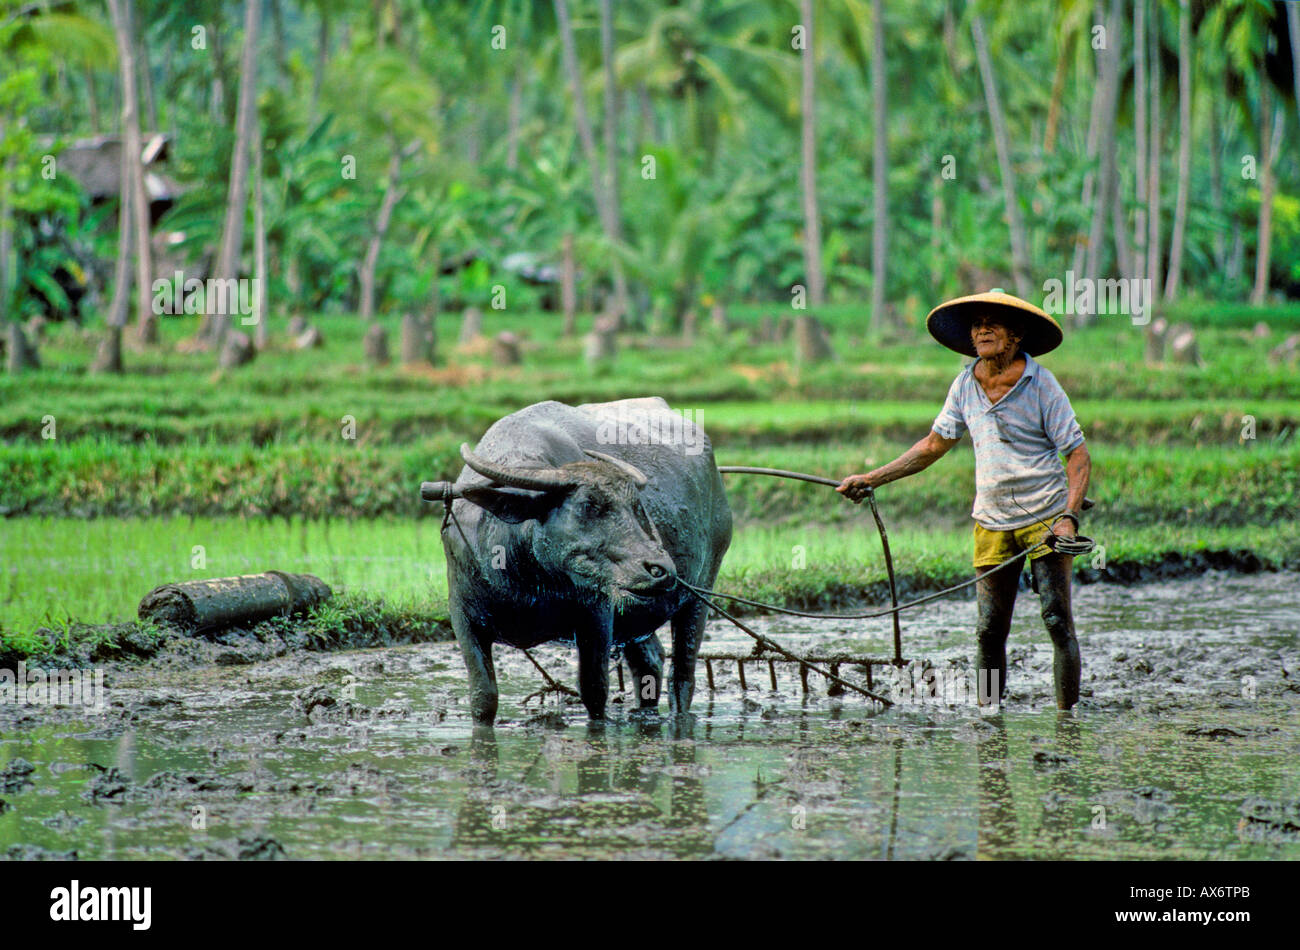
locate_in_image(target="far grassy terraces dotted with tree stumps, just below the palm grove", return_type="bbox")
[0,307,1300,444]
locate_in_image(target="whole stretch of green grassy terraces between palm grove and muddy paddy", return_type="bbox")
[0,302,1300,651]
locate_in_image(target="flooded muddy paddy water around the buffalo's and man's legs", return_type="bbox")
[0,574,1300,859]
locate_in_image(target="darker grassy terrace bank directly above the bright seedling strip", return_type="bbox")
[0,436,1300,524]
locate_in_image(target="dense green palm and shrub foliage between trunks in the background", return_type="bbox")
[0,0,1300,326]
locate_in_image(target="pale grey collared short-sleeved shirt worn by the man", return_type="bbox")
[932,351,1083,532]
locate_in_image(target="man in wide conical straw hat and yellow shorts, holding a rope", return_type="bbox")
[836,290,1092,710]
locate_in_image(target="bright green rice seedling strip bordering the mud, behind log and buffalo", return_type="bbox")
[0,512,1300,652]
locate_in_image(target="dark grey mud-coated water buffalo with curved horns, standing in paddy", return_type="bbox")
[426,396,732,724]
